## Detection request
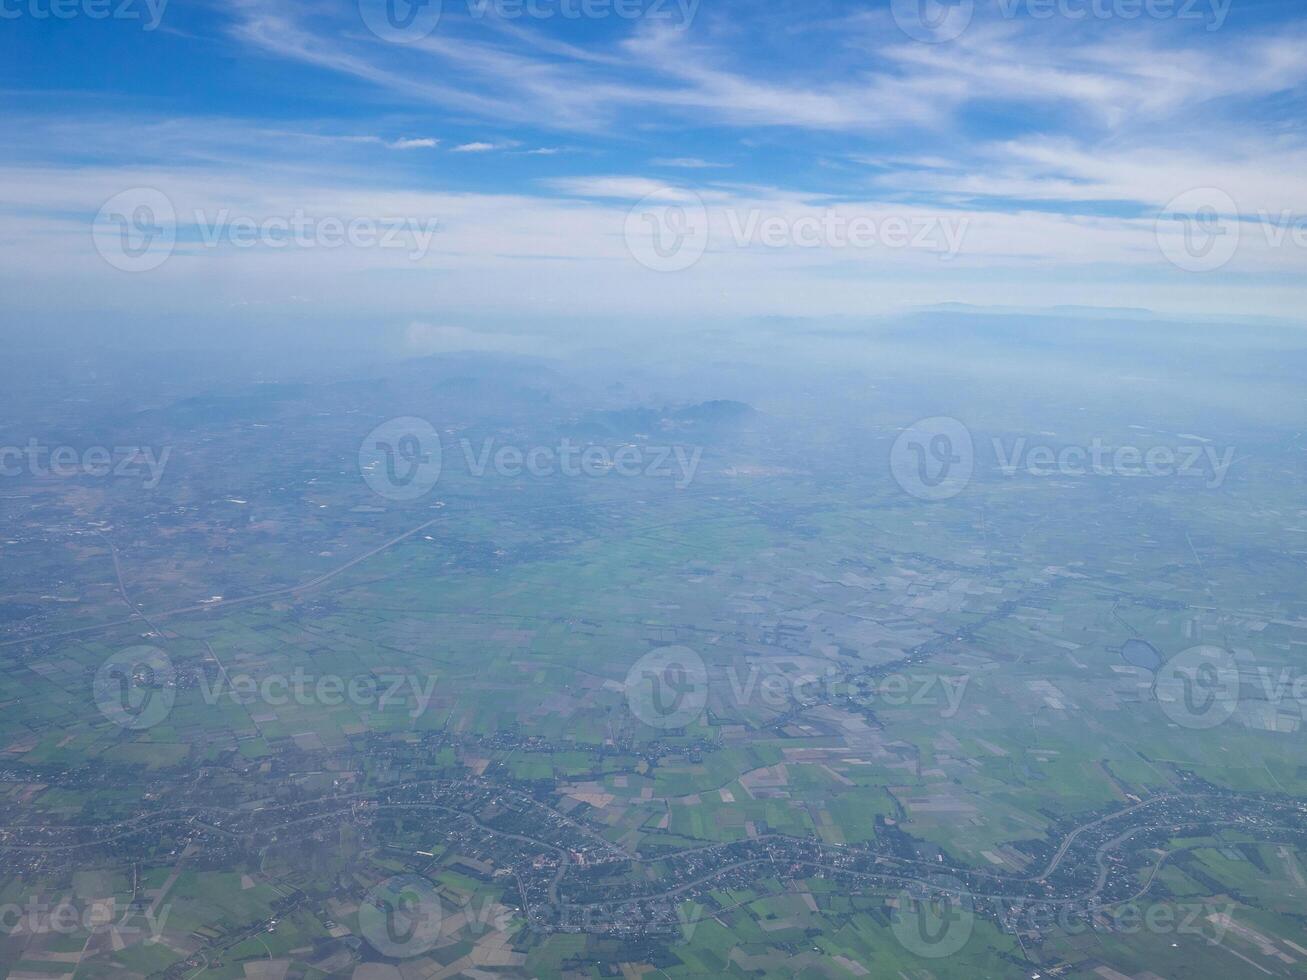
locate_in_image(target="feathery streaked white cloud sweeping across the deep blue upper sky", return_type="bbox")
[219,0,1307,145]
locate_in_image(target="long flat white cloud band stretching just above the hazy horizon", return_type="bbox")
[0,163,1307,327]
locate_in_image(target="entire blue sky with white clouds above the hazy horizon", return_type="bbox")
[0,0,1307,342]
